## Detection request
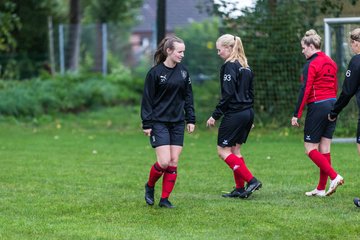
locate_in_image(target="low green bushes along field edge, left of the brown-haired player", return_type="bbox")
[0,68,142,117]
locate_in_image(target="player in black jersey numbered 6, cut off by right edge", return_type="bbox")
[329,28,360,207]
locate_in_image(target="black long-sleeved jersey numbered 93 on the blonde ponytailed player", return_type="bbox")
[212,61,254,120]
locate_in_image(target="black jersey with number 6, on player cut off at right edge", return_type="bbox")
[330,54,360,118]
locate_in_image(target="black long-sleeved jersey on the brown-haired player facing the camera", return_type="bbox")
[141,63,195,129]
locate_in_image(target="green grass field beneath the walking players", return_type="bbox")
[0,108,360,239]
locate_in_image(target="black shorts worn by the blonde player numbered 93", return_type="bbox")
[217,108,254,147]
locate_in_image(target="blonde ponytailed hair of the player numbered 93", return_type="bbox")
[216,34,249,67]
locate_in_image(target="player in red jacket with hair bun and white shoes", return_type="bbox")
[291,29,344,196]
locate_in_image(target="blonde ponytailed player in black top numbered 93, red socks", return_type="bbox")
[206,34,262,198]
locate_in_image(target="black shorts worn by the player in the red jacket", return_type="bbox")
[304,99,336,143]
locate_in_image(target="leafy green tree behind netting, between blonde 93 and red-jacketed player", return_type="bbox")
[205,0,360,124]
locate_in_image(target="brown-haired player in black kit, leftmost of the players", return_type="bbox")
[141,36,195,208]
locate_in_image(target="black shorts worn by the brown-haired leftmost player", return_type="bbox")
[150,122,185,148]
